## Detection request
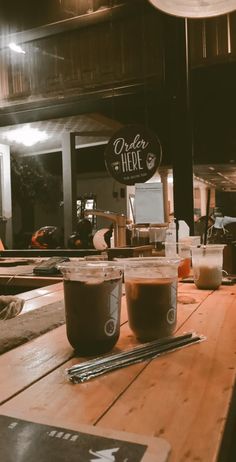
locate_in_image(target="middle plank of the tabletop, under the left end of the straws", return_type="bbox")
[1,324,146,426]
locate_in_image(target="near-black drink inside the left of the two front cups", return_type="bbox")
[64,276,122,355]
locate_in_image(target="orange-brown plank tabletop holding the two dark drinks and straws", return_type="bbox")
[0,283,236,462]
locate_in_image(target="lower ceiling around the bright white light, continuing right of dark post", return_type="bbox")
[0,113,236,192]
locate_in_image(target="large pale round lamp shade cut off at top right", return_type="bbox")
[149,0,236,18]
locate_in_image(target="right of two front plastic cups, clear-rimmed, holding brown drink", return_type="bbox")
[123,257,179,342]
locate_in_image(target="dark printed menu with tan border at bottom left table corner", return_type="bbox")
[0,415,170,462]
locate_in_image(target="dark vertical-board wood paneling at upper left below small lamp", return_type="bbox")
[0,7,163,104]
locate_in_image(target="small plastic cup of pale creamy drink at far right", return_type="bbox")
[191,244,225,290]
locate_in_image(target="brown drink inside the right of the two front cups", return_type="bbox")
[125,277,177,341]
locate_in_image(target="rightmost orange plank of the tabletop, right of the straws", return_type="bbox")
[94,286,236,462]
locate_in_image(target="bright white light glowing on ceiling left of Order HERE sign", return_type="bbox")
[2,125,49,146]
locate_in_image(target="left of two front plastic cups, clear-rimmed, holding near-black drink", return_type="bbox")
[59,261,123,356]
